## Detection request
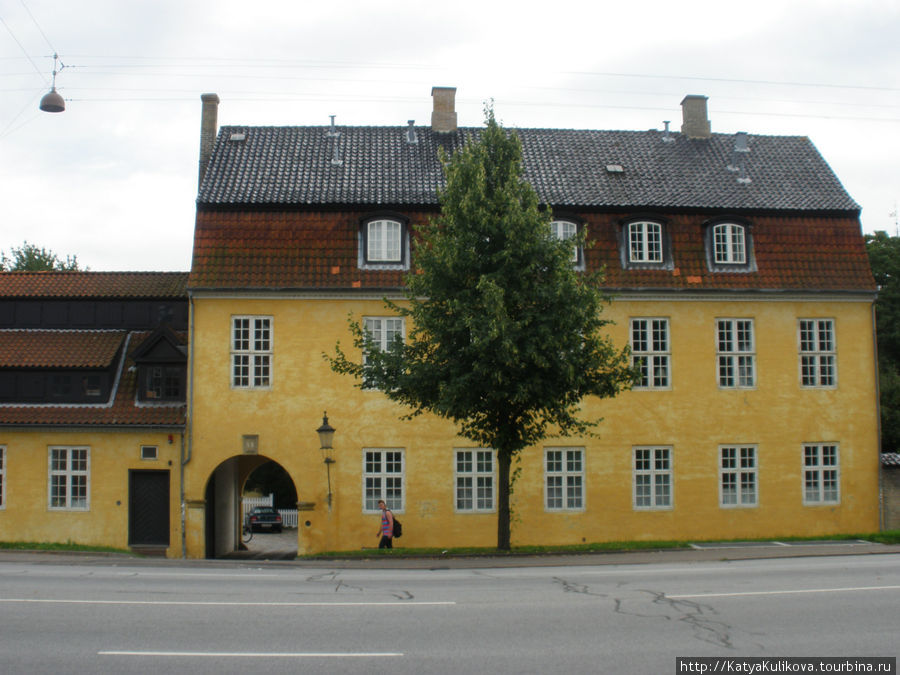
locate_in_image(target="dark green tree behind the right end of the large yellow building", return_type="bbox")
[866,232,900,452]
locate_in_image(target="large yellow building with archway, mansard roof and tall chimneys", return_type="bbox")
[183,88,878,557]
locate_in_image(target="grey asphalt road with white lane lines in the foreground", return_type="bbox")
[0,554,900,675]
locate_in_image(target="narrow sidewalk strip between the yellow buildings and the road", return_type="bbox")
[0,540,900,569]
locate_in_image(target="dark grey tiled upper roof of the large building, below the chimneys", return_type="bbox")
[198,126,859,212]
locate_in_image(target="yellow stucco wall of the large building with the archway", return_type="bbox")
[185,295,878,557]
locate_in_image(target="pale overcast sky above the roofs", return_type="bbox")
[0,0,900,271]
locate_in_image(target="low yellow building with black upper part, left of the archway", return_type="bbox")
[0,272,188,556]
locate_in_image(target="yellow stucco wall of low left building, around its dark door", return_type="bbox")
[0,430,181,557]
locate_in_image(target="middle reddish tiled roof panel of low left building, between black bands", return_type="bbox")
[0,330,125,368]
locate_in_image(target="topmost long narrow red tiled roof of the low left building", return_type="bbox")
[0,272,188,299]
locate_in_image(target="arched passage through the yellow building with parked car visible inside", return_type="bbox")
[206,455,298,560]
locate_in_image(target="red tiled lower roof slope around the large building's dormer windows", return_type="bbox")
[189,209,875,291]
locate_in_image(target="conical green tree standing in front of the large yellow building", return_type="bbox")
[329,108,634,550]
